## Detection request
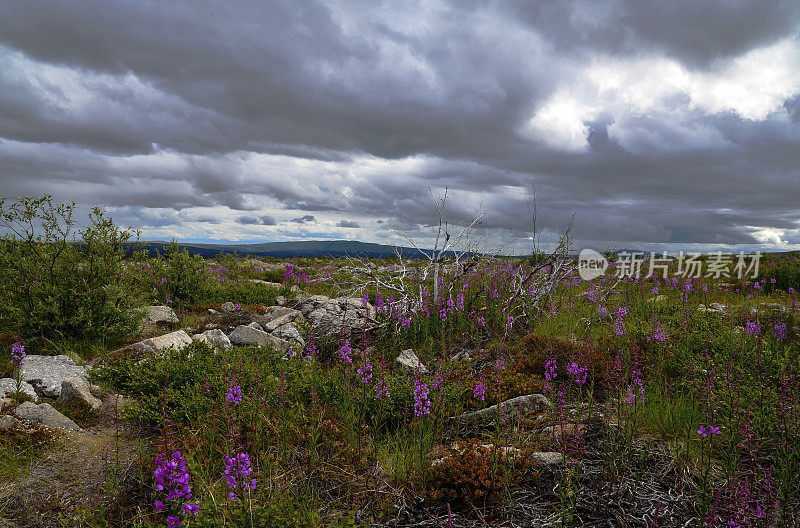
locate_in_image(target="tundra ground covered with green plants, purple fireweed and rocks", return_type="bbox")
[0,197,800,528]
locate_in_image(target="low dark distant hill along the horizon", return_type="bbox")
[128,240,462,258]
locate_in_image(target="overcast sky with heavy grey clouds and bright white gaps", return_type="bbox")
[0,0,800,254]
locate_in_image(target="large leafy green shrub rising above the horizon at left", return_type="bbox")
[0,195,142,340]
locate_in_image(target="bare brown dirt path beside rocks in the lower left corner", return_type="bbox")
[0,396,140,528]
